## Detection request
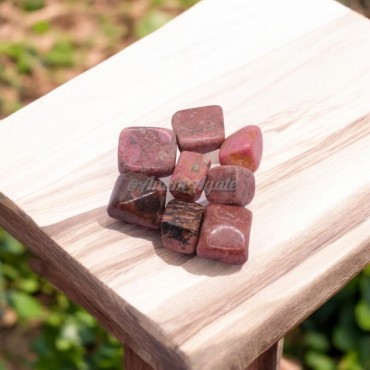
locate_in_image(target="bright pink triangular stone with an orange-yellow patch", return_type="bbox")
[219,125,263,172]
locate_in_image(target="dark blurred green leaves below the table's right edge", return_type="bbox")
[285,266,370,370]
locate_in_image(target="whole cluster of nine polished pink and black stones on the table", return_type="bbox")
[108,105,263,264]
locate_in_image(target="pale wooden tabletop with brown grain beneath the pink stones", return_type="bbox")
[0,0,370,370]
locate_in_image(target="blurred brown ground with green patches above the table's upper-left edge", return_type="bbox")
[0,0,198,119]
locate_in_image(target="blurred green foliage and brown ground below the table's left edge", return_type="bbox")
[0,230,122,370]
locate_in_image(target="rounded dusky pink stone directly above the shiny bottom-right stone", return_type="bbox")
[204,166,255,207]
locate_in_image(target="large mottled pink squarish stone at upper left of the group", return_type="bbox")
[118,127,177,177]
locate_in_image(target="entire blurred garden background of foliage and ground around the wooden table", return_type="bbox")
[0,0,370,370]
